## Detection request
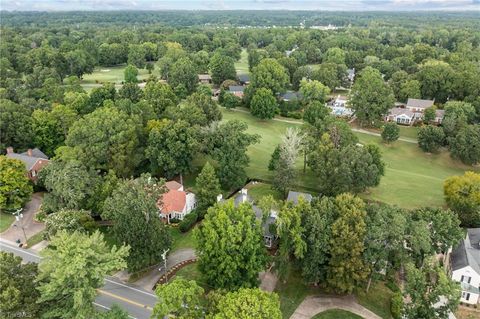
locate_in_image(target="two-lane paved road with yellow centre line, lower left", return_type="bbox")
[0,239,157,319]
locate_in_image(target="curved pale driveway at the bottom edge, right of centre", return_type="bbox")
[290,296,381,319]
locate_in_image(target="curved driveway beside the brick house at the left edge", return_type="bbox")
[0,193,45,242]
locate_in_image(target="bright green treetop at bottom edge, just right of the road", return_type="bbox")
[152,277,204,319]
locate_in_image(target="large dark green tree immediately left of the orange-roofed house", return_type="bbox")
[102,176,171,272]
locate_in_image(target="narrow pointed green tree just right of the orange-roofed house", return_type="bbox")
[195,162,222,218]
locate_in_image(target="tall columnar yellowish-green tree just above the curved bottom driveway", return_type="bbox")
[327,194,368,293]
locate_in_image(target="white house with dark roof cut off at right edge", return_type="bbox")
[450,228,480,305]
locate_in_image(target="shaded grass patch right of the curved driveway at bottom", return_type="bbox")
[355,281,393,319]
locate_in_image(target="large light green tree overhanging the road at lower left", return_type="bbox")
[38,231,129,319]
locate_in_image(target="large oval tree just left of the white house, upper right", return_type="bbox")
[349,66,395,126]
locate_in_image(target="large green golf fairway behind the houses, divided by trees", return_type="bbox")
[222,109,479,208]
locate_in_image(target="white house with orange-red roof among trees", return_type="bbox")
[157,181,197,224]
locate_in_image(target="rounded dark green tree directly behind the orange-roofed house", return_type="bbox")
[145,120,198,178]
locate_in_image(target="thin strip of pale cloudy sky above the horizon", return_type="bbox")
[0,0,480,11]
